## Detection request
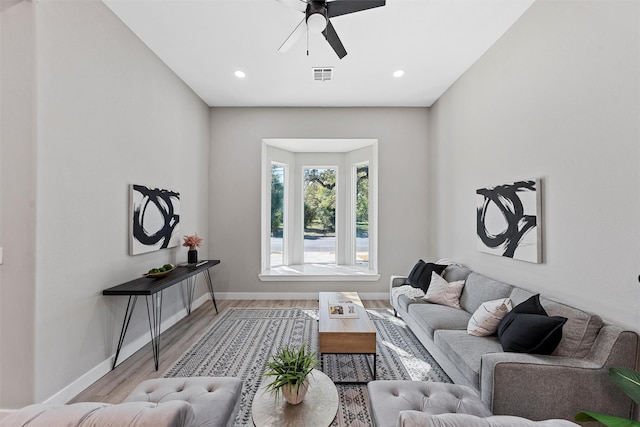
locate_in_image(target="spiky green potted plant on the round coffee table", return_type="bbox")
[264,345,318,405]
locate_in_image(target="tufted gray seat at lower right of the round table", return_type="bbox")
[367,381,493,427]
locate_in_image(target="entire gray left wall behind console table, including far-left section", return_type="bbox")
[0,1,209,408]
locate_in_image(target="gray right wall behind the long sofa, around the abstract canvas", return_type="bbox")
[428,1,640,331]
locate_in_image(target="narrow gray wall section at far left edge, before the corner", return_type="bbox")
[0,1,36,408]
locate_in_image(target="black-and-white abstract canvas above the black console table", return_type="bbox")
[129,184,180,255]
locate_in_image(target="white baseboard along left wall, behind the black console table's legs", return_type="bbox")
[42,292,211,406]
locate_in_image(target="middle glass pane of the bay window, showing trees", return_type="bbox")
[303,168,336,264]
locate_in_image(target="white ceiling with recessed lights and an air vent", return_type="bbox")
[103,0,534,107]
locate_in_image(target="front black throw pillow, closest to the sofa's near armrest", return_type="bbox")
[500,313,567,354]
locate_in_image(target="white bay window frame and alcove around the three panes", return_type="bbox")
[258,139,380,281]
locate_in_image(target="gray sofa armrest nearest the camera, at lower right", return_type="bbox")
[480,326,638,420]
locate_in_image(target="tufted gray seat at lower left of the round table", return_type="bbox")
[123,377,242,427]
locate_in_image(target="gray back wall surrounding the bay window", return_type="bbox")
[209,108,429,298]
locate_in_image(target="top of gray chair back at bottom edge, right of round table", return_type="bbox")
[396,411,578,427]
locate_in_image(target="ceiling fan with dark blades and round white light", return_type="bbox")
[277,0,385,59]
